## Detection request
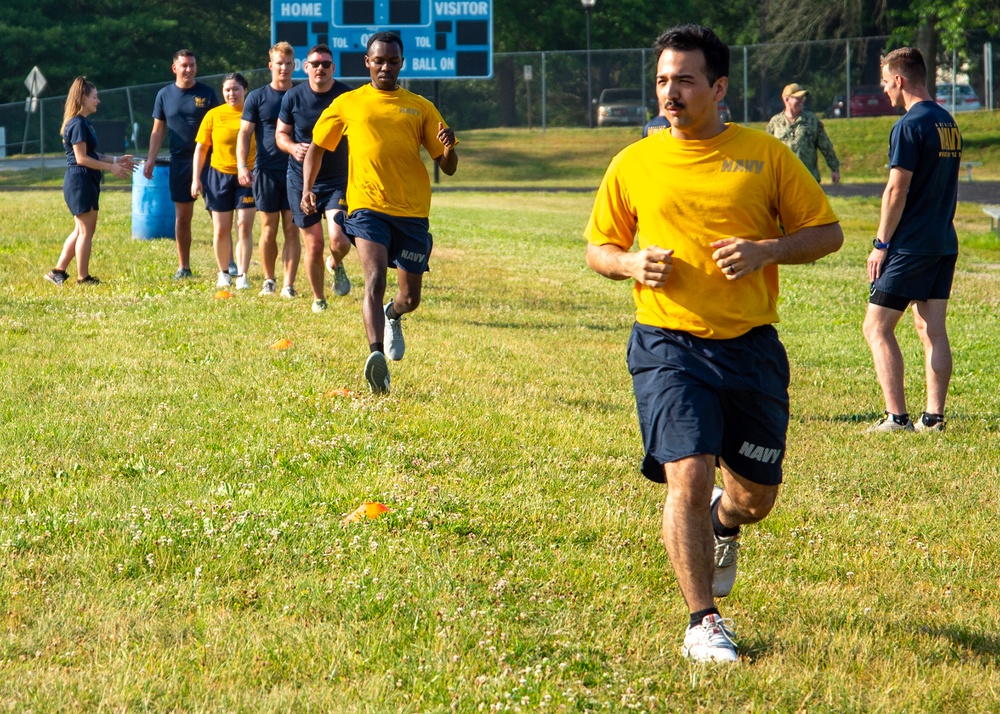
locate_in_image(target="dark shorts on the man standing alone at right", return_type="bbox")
[868,253,958,311]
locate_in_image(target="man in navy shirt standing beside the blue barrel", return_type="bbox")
[142,50,219,279]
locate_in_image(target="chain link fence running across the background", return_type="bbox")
[0,33,1000,175]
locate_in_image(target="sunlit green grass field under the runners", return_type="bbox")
[0,165,1000,713]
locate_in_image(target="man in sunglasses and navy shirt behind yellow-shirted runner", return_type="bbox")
[274,45,351,312]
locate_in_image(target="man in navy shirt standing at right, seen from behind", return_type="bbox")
[864,47,962,431]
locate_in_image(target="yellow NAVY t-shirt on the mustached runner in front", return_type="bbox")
[584,124,837,339]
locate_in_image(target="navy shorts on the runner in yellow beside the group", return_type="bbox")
[336,208,434,274]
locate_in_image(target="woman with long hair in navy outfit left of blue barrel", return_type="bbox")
[45,77,134,285]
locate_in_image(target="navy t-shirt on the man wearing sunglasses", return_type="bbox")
[279,79,351,189]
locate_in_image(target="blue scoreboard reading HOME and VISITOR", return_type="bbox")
[271,0,493,79]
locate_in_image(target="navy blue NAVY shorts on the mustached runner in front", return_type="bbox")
[628,323,789,486]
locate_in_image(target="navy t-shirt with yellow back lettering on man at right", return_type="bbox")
[889,100,962,255]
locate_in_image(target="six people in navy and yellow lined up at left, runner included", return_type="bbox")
[45,32,458,393]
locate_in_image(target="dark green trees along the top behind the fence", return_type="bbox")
[0,0,1000,103]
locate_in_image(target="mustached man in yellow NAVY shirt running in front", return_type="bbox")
[585,25,844,662]
